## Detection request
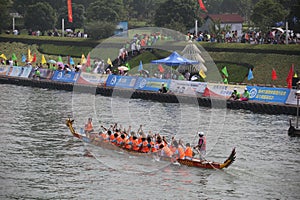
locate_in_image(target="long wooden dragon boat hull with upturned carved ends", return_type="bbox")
[66,119,236,169]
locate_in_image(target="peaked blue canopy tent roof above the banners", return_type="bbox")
[151,51,199,66]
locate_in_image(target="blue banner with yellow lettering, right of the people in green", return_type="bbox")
[247,86,290,103]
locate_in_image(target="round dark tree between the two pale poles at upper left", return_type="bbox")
[24,2,56,32]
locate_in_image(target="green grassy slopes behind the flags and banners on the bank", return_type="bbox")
[0,35,300,87]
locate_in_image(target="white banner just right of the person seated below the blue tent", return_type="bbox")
[170,80,207,95]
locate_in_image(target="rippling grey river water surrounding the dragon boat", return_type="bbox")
[0,85,300,199]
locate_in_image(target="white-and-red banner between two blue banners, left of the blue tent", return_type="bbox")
[77,72,108,85]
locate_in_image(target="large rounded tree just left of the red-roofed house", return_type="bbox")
[154,0,199,31]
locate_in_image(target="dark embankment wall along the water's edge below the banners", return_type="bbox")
[0,76,297,115]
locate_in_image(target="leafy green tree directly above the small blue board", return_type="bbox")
[87,0,126,22]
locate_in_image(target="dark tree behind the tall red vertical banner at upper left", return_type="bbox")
[57,3,85,30]
